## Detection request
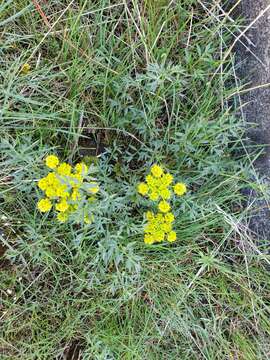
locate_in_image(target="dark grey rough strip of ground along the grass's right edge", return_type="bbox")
[237,0,270,239]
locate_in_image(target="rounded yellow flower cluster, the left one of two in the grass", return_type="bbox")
[37,155,99,223]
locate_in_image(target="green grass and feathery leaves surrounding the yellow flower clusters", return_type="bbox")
[0,0,270,360]
